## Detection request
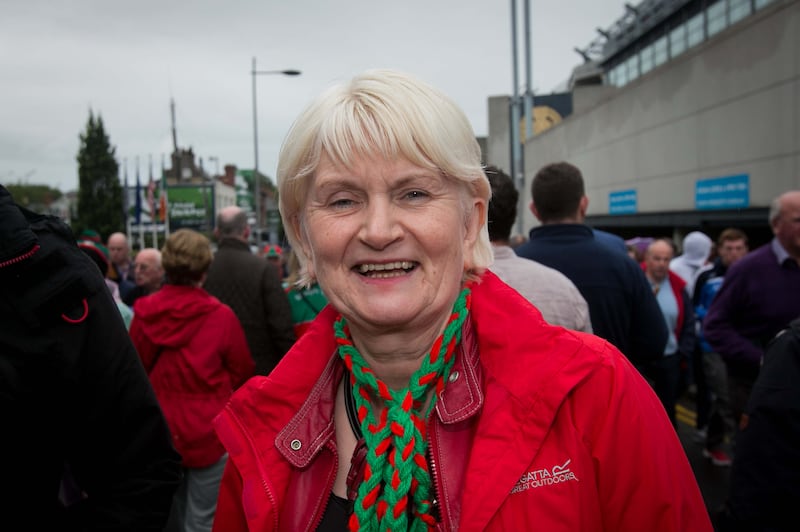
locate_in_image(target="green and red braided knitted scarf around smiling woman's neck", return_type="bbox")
[334,288,471,531]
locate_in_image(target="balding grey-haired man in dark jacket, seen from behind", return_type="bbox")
[203,206,295,375]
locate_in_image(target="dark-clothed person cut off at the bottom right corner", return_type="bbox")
[716,316,800,532]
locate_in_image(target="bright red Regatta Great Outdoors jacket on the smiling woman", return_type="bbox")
[214,272,711,532]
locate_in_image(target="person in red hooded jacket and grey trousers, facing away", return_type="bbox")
[130,229,255,531]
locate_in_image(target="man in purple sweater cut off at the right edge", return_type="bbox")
[703,190,800,426]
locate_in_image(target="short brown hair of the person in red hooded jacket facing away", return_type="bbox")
[161,229,213,285]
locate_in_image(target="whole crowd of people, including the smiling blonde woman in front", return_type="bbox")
[0,70,800,532]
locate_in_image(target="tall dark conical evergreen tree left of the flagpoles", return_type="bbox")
[72,110,125,239]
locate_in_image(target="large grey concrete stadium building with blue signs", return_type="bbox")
[485,0,800,243]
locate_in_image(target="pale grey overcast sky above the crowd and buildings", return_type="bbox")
[0,0,624,191]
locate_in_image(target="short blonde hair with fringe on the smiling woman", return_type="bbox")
[277,70,492,286]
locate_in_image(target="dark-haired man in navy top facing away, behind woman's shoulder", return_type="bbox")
[514,162,669,369]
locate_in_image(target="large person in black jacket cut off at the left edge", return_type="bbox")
[0,185,181,532]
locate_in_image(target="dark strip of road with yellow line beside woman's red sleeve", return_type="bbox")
[676,394,731,517]
